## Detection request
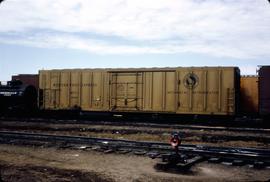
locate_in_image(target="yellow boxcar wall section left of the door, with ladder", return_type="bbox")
[40,70,109,111]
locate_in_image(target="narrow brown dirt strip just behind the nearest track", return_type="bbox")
[1,125,270,143]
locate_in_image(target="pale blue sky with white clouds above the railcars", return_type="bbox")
[0,0,270,80]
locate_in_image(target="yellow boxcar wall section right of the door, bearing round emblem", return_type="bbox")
[176,67,236,115]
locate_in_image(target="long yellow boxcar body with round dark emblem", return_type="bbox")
[39,67,240,115]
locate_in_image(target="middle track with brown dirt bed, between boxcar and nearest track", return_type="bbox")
[0,120,270,146]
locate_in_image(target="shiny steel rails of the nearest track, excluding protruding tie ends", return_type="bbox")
[0,132,270,163]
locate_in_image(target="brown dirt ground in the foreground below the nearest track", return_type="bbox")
[0,145,270,182]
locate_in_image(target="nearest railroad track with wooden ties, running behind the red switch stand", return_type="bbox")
[0,132,270,166]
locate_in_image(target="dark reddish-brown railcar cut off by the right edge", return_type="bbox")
[259,66,270,116]
